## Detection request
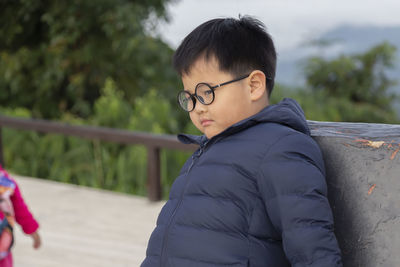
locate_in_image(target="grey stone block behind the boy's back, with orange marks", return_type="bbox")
[309,121,400,267]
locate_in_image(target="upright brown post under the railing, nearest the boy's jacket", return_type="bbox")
[147,146,162,201]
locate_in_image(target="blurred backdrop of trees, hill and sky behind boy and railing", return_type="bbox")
[0,0,400,196]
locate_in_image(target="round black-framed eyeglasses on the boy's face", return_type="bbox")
[178,74,250,112]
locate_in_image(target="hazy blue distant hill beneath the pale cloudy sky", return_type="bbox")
[276,25,400,94]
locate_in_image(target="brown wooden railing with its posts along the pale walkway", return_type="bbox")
[0,115,196,201]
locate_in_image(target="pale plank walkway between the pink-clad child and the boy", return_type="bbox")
[13,176,163,267]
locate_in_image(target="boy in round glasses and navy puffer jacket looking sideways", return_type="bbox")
[141,16,342,267]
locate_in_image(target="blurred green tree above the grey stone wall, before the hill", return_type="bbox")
[296,42,398,123]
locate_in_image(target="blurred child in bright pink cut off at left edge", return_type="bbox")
[0,165,41,267]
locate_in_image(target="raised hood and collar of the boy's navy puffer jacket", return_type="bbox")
[178,98,310,146]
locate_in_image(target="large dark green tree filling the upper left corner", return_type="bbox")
[0,0,179,118]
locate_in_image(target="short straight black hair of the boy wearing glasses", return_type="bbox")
[173,16,276,96]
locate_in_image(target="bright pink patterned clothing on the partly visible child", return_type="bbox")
[0,166,39,267]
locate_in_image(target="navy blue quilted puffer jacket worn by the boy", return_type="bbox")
[141,99,342,267]
